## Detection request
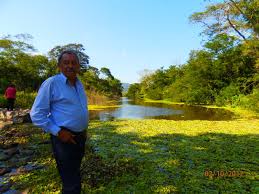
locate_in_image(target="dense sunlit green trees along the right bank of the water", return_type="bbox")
[133,34,258,105]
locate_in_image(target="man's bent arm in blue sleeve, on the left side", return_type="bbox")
[30,79,60,136]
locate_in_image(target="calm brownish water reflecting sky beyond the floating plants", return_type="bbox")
[90,97,236,121]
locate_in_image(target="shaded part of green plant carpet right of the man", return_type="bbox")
[84,124,259,193]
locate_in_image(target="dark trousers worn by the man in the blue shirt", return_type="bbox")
[51,130,86,194]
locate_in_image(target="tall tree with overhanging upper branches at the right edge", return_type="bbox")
[190,0,259,99]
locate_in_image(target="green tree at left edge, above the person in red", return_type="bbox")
[0,34,45,90]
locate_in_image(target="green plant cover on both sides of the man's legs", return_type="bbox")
[8,119,259,194]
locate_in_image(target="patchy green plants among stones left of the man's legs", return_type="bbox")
[2,124,61,193]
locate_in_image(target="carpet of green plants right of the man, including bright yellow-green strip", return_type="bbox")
[86,120,259,193]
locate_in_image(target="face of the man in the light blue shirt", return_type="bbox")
[59,53,80,79]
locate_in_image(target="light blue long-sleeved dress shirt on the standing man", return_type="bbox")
[30,73,88,135]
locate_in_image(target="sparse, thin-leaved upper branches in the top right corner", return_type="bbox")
[190,0,259,40]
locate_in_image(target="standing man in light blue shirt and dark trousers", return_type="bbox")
[30,51,88,194]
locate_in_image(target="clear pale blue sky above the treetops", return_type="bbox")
[0,0,213,83]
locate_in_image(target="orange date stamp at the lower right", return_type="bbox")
[204,170,245,177]
